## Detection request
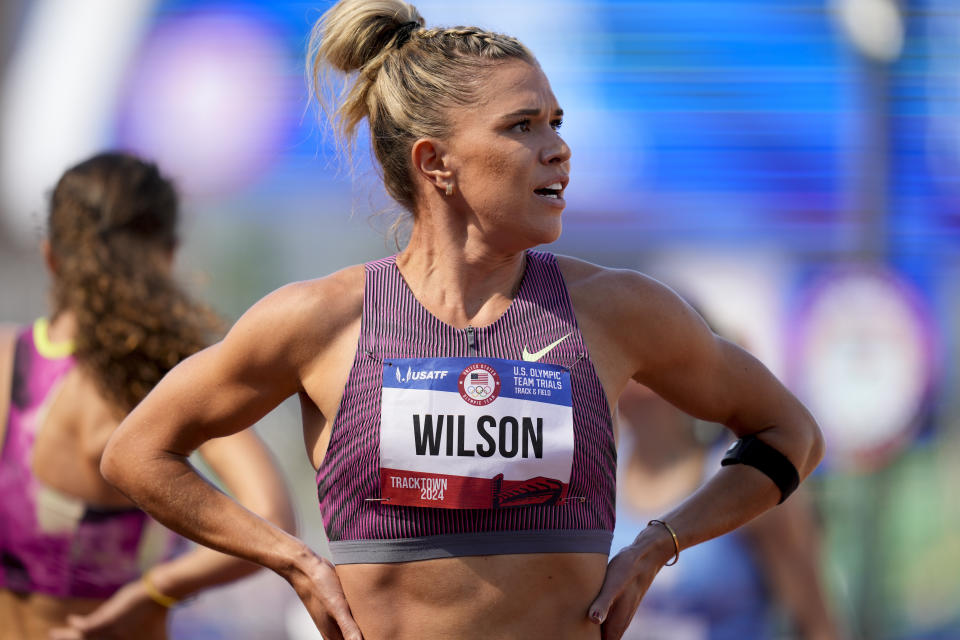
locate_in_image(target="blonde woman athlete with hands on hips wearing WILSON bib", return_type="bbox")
[102,5,822,640]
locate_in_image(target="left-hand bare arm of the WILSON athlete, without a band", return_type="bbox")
[101,272,360,638]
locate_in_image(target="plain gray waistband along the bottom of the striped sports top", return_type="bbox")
[330,529,613,564]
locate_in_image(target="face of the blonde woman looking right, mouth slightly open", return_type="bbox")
[446,60,570,250]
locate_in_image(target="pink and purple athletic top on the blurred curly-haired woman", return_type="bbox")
[0,320,169,598]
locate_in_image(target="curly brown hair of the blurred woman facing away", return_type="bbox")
[48,152,221,411]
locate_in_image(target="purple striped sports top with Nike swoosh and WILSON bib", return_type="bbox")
[317,251,616,564]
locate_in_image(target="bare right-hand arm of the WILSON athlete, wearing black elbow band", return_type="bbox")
[571,265,823,638]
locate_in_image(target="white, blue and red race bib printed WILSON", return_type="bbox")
[380,358,573,509]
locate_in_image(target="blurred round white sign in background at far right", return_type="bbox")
[790,266,935,467]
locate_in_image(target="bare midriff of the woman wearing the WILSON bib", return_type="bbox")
[337,553,607,640]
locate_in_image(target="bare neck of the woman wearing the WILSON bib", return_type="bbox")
[397,224,525,328]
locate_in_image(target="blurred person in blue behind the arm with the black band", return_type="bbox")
[611,382,842,640]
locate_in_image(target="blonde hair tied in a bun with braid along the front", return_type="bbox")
[307,0,537,212]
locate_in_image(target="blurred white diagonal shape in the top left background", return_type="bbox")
[0,0,156,242]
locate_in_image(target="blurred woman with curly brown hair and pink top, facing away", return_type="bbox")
[0,153,294,640]
